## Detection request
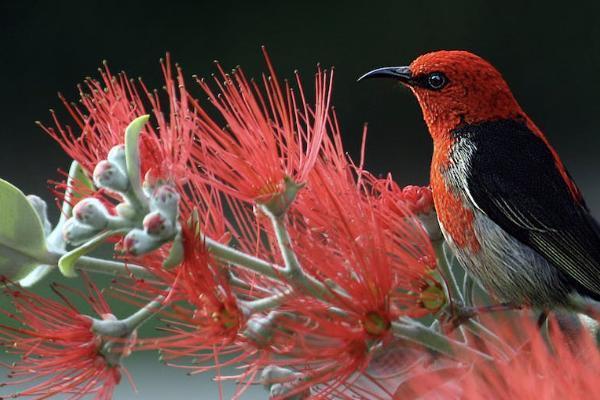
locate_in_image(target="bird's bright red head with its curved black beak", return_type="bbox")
[359,50,524,140]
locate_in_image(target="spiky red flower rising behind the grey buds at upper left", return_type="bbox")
[40,54,194,184]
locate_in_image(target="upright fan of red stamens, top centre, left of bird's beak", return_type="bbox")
[194,48,333,203]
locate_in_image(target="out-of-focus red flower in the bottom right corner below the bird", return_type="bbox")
[394,317,600,400]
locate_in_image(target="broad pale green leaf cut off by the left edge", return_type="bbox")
[0,179,50,281]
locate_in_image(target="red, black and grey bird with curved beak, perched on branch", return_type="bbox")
[361,51,600,309]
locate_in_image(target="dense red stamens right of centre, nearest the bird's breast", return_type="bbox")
[290,112,435,321]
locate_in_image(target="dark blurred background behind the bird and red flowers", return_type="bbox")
[0,0,600,399]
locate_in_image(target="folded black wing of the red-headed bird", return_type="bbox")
[453,120,600,298]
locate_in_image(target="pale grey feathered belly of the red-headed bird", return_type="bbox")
[442,209,570,308]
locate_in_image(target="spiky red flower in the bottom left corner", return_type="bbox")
[0,282,131,399]
